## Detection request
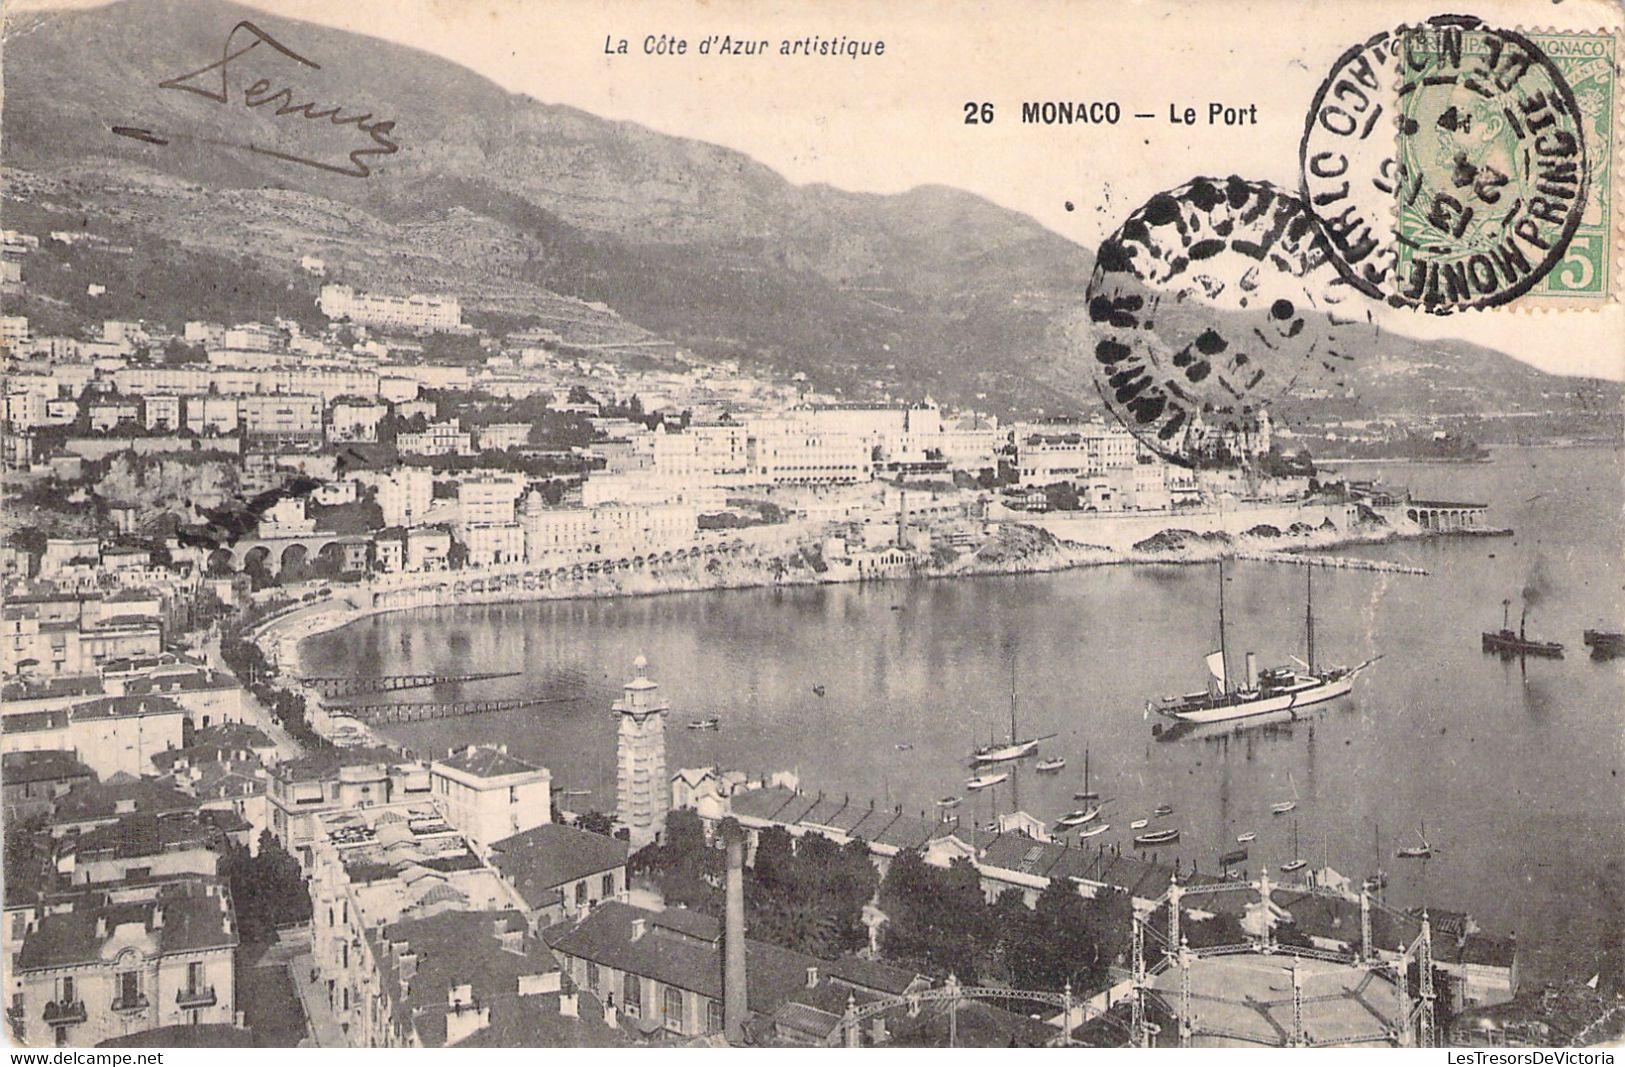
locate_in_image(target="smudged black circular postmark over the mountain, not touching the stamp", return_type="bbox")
[1087,177,1363,466]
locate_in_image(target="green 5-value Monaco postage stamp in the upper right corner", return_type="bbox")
[1389,16,1615,313]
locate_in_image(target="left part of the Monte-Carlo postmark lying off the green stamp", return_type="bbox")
[1298,29,1399,299]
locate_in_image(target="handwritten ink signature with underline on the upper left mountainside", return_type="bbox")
[112,19,400,179]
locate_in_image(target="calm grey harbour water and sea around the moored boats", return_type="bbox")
[304,448,1625,973]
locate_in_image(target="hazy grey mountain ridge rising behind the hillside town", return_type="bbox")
[0,0,1612,422]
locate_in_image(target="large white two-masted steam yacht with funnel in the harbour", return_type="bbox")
[1146,559,1376,723]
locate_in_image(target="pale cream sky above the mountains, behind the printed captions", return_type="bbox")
[15,0,1625,378]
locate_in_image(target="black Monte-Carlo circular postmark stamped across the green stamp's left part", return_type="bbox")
[1298,15,1591,315]
